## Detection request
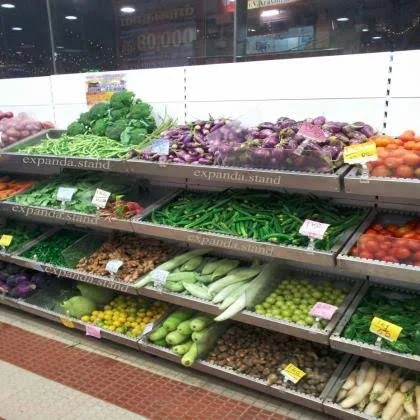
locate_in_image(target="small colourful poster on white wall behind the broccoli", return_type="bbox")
[86,73,127,106]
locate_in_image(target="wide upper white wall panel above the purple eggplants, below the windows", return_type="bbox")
[186,52,390,101]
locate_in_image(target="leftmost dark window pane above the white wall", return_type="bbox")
[0,0,53,78]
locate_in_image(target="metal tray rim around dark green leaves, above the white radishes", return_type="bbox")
[330,284,420,372]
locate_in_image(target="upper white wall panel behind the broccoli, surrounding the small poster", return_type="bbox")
[51,67,184,105]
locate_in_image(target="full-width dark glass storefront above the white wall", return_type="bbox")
[0,0,420,78]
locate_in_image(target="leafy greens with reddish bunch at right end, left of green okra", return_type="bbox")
[12,173,142,219]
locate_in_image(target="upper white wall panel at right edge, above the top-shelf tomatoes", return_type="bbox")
[390,50,420,98]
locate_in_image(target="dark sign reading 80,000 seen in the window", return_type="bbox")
[114,0,196,69]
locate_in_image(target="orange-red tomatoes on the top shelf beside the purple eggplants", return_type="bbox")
[368,130,420,178]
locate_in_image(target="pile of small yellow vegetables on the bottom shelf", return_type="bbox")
[80,296,168,337]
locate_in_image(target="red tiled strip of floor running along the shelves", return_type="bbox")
[0,322,290,420]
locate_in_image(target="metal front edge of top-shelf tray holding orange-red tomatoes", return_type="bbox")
[344,168,420,200]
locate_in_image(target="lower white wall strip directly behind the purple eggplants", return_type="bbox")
[187,98,384,130]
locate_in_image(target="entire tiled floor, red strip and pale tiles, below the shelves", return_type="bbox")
[0,307,328,420]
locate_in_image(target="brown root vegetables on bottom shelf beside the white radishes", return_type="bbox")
[207,325,340,396]
